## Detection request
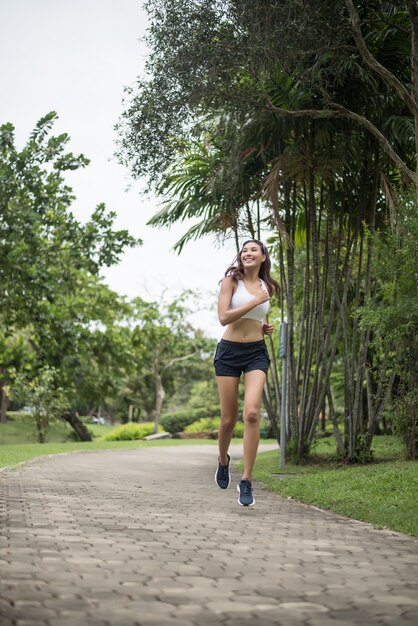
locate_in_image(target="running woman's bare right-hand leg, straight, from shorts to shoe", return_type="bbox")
[242,370,266,480]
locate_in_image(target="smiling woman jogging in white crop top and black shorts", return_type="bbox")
[214,239,279,506]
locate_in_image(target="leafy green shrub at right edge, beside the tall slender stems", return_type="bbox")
[360,197,418,459]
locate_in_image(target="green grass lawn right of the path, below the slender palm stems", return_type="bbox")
[242,436,418,536]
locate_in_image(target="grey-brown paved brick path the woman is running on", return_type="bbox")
[0,445,418,626]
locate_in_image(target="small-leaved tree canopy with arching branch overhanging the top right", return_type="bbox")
[119,0,418,190]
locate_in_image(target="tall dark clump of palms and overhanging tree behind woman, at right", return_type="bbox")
[119,0,418,461]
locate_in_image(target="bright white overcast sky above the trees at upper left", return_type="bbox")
[0,0,234,338]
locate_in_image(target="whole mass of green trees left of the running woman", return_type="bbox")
[0,113,216,442]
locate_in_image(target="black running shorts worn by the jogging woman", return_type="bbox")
[213,339,270,378]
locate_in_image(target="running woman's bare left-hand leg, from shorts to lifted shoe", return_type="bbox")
[216,376,239,465]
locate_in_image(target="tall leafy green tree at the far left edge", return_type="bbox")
[0,113,140,434]
